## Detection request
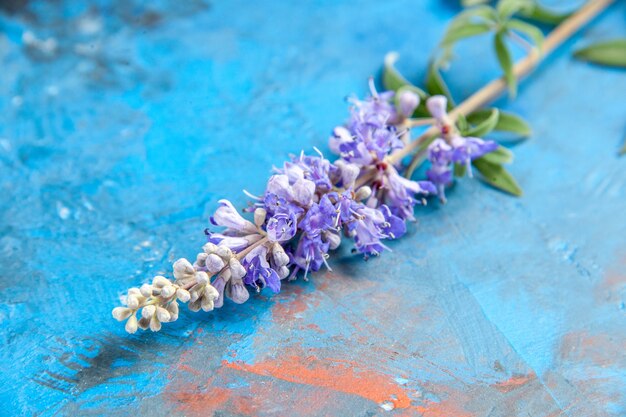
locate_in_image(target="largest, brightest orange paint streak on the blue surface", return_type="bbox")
[222,356,411,408]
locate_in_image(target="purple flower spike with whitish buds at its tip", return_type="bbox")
[113,83,491,333]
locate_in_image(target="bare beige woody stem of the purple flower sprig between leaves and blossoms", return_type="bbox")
[388,0,615,163]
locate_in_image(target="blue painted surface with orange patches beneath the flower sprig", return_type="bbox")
[0,0,626,416]
